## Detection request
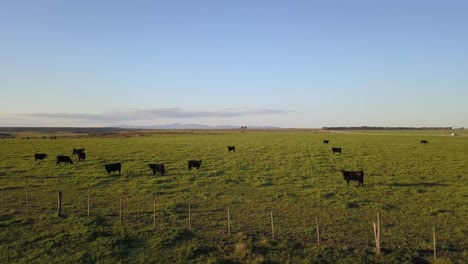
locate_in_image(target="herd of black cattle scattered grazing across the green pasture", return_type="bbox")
[34,139,429,186]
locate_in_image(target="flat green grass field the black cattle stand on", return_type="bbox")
[0,130,468,263]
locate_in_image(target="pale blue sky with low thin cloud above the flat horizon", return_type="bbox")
[0,0,468,128]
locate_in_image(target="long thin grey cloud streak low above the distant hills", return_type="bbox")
[19,108,291,123]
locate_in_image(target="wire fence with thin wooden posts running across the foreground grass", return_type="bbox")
[0,187,468,260]
